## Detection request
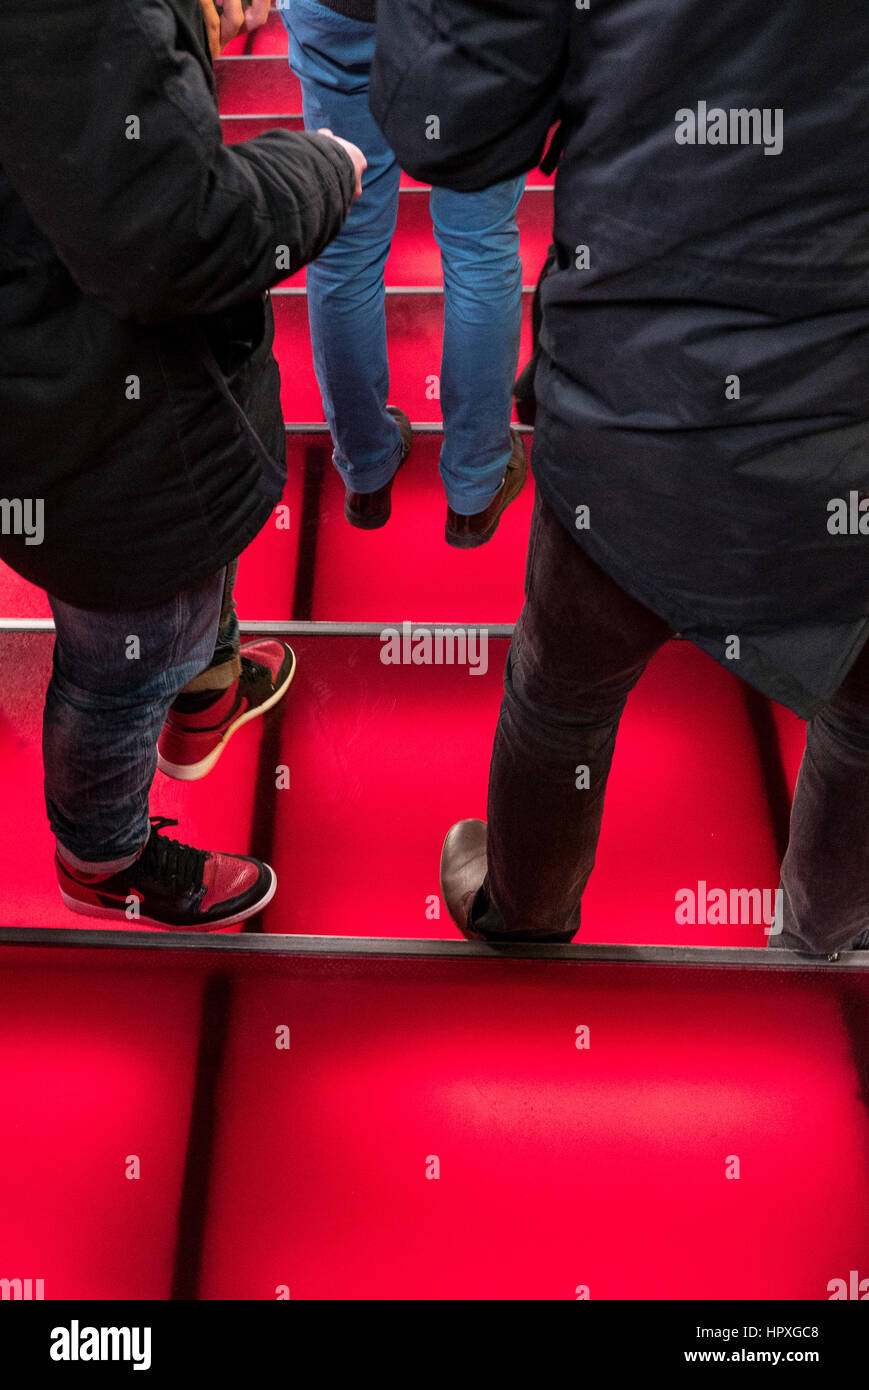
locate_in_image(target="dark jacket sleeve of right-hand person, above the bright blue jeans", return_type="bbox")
[370,0,567,192]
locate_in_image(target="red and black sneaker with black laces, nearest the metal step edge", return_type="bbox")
[56,816,278,931]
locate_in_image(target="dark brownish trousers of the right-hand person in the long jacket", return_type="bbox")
[471,493,869,954]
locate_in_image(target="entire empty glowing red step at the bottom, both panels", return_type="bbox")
[0,945,869,1302]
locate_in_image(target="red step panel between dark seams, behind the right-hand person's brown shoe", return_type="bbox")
[260,636,779,947]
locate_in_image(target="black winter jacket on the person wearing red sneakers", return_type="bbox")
[0,0,353,610]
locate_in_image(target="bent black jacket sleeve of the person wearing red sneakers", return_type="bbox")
[0,0,353,322]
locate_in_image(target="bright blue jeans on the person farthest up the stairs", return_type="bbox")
[281,0,524,516]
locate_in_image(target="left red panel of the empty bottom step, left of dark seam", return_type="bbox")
[0,950,203,1300]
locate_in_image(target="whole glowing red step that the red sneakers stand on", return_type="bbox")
[0,631,777,945]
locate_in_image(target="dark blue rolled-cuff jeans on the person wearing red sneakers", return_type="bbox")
[42,564,239,873]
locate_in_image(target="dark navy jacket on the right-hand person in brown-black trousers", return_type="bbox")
[370,0,869,716]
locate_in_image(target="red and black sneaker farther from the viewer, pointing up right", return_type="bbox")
[157,642,296,781]
